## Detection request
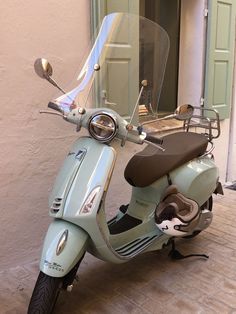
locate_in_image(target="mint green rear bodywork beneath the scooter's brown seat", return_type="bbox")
[128,157,219,219]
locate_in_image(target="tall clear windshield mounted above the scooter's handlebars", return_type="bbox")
[53,13,169,123]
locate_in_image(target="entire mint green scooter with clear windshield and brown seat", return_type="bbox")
[28,13,222,313]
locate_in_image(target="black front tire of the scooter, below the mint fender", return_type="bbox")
[27,272,63,314]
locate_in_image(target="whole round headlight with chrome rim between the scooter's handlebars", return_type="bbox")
[88,113,117,142]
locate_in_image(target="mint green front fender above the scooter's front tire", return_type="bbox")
[40,219,89,277]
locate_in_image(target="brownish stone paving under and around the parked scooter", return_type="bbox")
[0,189,236,314]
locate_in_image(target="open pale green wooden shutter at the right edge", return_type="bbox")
[204,0,236,119]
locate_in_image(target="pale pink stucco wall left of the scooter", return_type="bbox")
[0,0,90,270]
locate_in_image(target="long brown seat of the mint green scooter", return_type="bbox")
[125,132,208,187]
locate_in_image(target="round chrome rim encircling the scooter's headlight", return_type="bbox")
[88,111,118,143]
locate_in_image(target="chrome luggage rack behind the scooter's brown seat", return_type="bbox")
[183,106,220,142]
